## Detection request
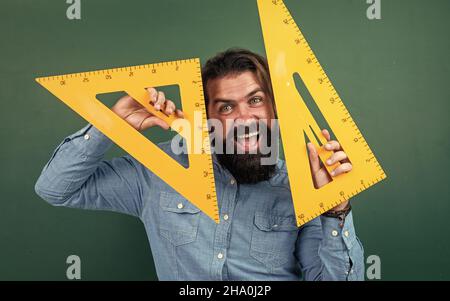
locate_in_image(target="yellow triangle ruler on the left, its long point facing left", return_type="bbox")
[36,59,219,223]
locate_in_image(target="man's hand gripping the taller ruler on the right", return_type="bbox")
[307,129,352,211]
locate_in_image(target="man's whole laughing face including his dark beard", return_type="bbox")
[206,71,275,184]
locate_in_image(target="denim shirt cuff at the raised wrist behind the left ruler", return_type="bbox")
[66,124,113,157]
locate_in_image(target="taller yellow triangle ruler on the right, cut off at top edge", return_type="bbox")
[258,0,386,225]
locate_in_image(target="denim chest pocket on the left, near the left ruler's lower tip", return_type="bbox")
[159,191,200,246]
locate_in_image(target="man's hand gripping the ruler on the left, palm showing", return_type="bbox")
[111,88,183,131]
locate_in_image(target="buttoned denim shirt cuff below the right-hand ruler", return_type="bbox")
[320,211,356,250]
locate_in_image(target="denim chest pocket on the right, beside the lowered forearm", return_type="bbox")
[250,213,298,271]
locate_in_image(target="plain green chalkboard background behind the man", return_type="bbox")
[0,0,450,280]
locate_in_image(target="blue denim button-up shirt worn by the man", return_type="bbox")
[35,125,364,280]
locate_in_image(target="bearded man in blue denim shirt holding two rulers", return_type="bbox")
[35,49,364,280]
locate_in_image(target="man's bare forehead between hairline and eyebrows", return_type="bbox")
[206,71,262,100]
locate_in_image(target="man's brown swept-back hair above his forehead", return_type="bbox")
[202,48,275,109]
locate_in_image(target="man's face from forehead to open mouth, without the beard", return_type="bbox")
[206,71,275,153]
